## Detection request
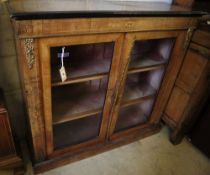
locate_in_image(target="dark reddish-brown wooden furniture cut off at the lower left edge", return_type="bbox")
[0,90,23,170]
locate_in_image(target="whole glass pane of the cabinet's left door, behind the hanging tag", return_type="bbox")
[50,42,114,149]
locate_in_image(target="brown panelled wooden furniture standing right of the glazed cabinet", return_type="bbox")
[164,17,210,143]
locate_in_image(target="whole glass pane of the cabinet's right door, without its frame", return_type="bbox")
[114,38,175,132]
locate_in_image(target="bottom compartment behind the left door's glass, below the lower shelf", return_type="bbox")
[53,114,101,149]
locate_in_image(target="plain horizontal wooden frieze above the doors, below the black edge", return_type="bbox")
[12,17,199,38]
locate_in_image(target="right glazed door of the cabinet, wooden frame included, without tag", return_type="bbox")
[109,31,186,139]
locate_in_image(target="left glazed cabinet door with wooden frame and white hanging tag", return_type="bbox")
[39,34,123,157]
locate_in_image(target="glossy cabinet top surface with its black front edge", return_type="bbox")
[7,0,205,20]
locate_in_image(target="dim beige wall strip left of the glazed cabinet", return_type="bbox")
[0,1,26,139]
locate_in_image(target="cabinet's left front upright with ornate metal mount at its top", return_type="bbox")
[16,39,45,162]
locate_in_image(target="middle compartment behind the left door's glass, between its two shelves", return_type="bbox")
[52,79,107,124]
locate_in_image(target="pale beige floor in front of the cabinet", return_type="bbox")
[0,127,210,175]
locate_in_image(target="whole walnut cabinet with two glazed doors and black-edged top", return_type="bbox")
[6,1,201,173]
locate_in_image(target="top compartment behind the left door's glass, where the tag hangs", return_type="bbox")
[51,42,114,83]
